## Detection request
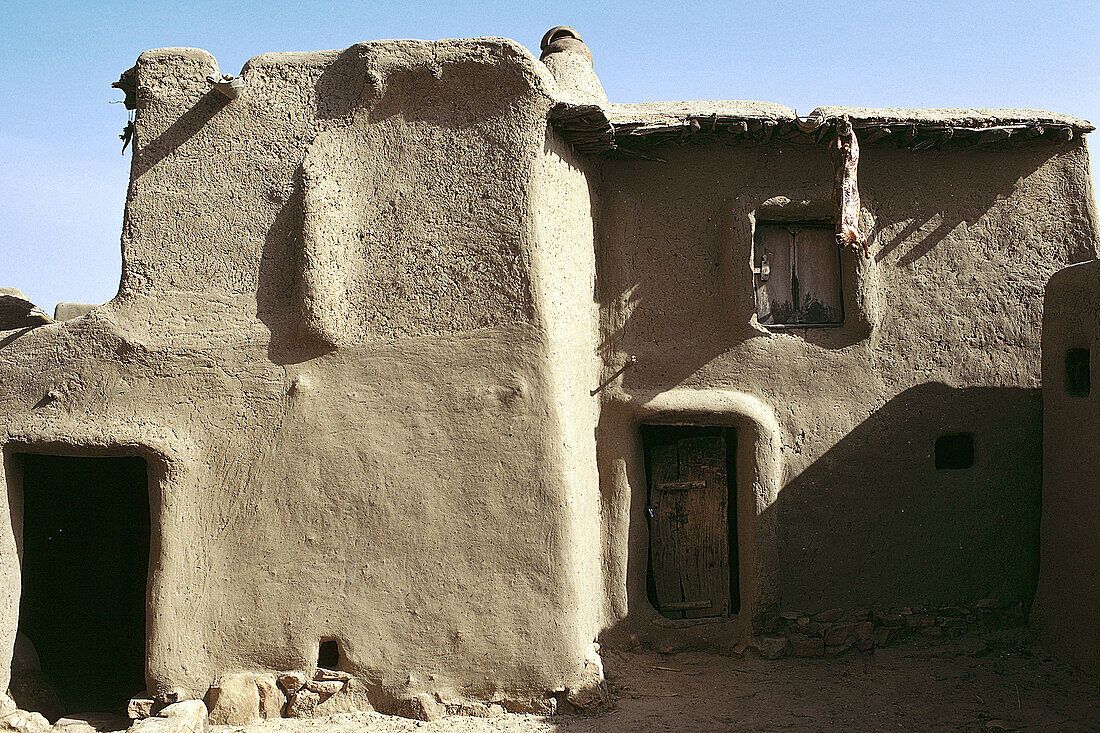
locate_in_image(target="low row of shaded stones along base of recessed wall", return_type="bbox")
[755,599,1027,659]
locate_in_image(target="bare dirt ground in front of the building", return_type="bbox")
[207,632,1100,733]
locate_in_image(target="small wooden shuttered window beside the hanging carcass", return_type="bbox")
[752,221,844,328]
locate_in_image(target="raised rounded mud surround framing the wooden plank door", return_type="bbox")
[597,389,783,649]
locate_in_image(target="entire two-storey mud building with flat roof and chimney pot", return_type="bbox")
[0,31,1097,714]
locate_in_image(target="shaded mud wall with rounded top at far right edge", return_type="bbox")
[1031,262,1100,675]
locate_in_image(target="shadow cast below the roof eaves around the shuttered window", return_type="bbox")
[598,142,1092,390]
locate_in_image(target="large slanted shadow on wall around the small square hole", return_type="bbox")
[770,383,1043,612]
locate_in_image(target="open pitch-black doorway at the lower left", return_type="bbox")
[18,453,150,712]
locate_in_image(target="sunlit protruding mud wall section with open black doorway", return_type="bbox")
[0,40,601,709]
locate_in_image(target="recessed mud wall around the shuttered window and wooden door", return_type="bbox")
[597,134,1097,648]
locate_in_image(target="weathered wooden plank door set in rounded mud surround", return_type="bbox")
[641,425,740,619]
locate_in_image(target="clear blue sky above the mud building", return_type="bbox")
[0,0,1100,310]
